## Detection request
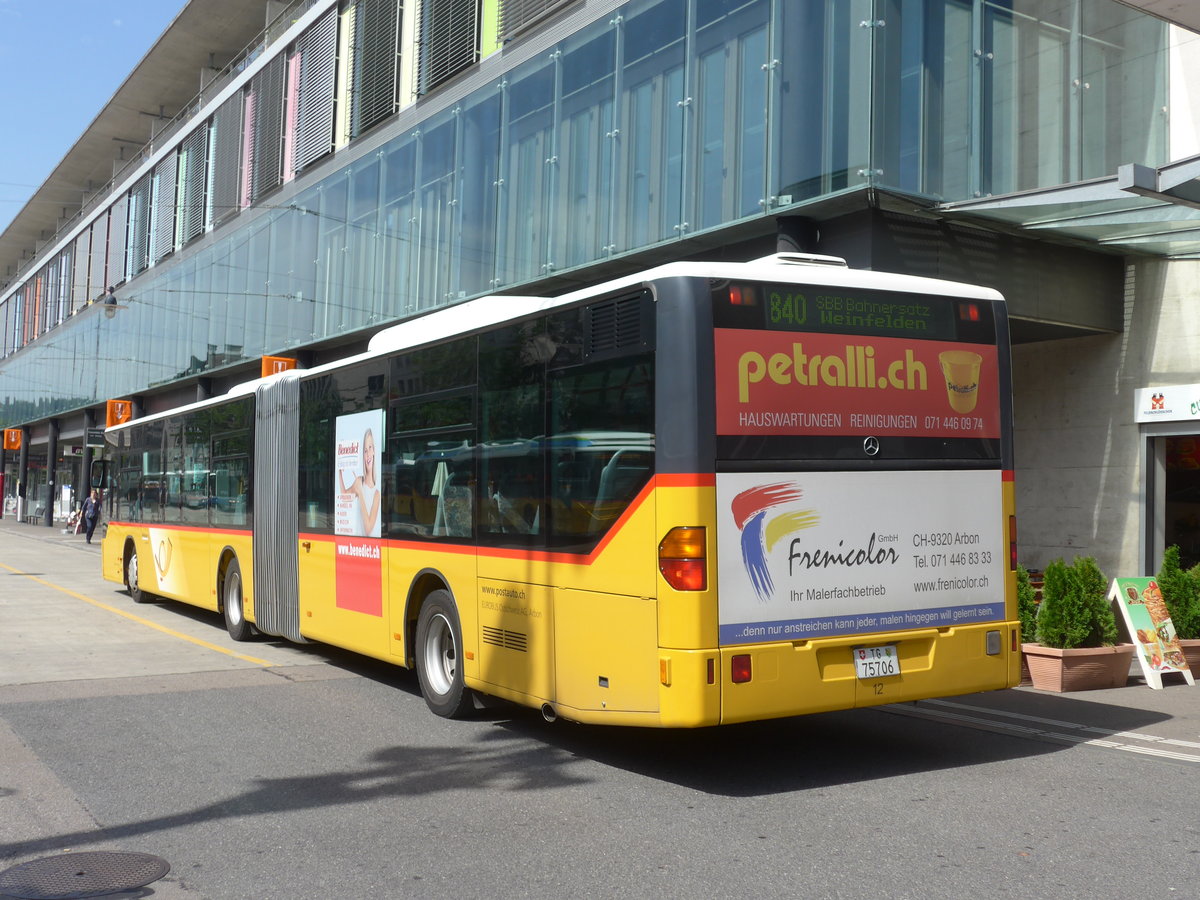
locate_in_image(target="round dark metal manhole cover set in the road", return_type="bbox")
[0,851,170,900]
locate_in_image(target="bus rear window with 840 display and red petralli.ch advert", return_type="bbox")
[713,282,1007,464]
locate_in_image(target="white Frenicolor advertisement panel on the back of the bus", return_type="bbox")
[716,472,1006,646]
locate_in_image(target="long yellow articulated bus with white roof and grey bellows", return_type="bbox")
[103,254,1020,727]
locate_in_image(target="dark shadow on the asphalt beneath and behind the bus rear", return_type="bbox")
[487,691,1171,797]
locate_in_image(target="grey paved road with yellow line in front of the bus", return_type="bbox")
[0,521,1200,900]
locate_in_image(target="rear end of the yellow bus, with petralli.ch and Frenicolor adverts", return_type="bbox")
[712,266,1020,722]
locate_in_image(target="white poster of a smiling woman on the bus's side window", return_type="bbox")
[334,409,384,538]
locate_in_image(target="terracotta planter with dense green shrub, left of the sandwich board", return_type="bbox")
[1021,557,1134,691]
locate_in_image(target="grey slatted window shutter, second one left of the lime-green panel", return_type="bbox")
[350,0,401,137]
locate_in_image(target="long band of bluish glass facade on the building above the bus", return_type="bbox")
[0,0,1168,424]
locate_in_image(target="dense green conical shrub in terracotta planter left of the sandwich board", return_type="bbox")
[1037,557,1117,649]
